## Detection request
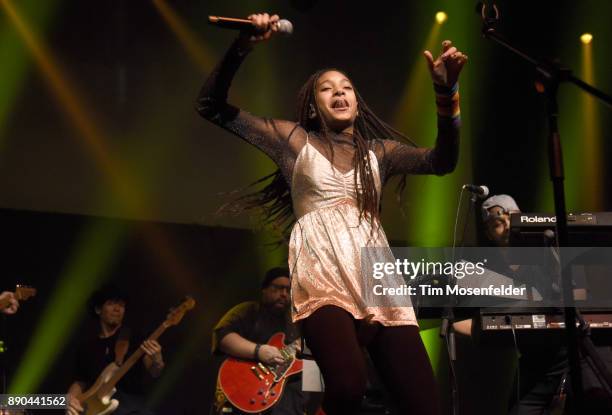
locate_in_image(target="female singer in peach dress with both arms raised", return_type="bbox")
[197,13,467,415]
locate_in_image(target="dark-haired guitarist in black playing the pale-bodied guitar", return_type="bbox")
[67,285,164,415]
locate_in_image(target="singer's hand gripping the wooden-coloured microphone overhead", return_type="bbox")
[208,13,293,44]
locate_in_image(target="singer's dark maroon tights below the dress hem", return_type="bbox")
[302,306,440,415]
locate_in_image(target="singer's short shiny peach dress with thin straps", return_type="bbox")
[289,139,417,326]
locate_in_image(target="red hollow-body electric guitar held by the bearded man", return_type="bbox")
[218,333,303,413]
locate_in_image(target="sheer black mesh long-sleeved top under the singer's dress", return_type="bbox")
[196,42,460,186]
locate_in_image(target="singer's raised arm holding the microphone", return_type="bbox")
[196,14,297,163]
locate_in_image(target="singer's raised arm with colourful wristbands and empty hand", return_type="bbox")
[382,41,467,178]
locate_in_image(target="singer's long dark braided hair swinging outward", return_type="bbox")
[220,68,417,239]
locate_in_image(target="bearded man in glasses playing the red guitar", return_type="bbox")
[212,268,305,415]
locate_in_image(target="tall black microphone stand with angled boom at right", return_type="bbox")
[478,4,612,408]
